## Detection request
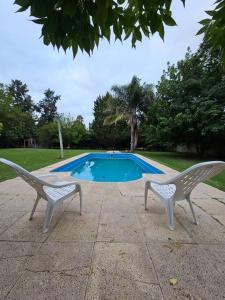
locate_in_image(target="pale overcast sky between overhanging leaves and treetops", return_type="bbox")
[0,0,213,124]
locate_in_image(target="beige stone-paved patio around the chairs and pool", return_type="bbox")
[0,159,225,300]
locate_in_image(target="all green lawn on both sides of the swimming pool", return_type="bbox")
[0,149,225,191]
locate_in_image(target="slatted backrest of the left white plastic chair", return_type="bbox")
[0,158,47,196]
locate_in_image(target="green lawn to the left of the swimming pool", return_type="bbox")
[0,148,99,181]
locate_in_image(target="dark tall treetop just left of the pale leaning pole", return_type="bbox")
[36,89,61,125]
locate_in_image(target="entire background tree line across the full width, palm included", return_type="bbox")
[0,43,225,156]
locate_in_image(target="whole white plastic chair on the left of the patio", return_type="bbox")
[0,158,82,233]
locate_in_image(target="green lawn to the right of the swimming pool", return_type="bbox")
[137,151,225,192]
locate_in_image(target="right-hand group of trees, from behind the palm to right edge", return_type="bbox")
[92,43,225,156]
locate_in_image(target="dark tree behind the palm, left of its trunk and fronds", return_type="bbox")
[90,93,129,149]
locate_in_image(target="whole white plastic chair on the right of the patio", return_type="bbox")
[145,161,225,230]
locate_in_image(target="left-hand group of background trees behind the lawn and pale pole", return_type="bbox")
[0,80,88,148]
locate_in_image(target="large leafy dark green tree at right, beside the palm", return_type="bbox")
[142,43,225,155]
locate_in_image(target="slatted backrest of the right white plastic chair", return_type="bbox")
[166,161,225,199]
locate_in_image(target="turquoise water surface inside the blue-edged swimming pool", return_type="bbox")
[72,158,143,182]
